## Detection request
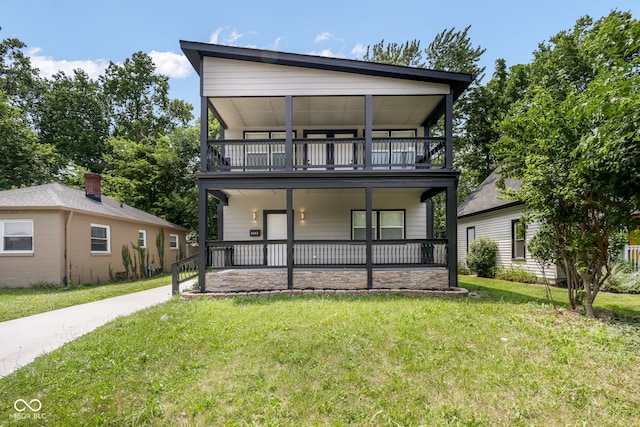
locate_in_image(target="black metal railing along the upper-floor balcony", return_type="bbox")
[207,138,446,172]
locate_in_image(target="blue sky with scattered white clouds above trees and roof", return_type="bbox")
[0,0,640,113]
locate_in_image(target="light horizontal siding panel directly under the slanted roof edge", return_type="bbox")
[203,58,449,97]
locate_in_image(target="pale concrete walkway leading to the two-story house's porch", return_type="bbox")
[0,282,192,378]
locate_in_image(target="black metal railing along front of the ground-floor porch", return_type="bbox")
[207,239,448,269]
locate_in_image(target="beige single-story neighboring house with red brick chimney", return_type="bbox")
[0,174,187,288]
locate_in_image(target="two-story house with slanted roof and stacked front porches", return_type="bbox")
[181,41,473,291]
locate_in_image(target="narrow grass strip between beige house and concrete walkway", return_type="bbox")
[0,275,171,322]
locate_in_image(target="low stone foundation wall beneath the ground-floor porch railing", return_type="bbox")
[206,268,449,292]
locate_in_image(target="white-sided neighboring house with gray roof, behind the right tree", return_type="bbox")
[458,171,565,282]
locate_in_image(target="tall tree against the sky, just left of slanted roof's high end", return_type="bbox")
[100,52,193,142]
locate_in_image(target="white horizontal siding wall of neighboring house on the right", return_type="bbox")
[458,206,564,280]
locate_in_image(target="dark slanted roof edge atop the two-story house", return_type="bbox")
[180,40,475,98]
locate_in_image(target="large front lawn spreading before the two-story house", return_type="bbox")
[0,277,640,426]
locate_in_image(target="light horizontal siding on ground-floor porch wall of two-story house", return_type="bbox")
[224,190,426,241]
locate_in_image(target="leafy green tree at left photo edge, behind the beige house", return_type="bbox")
[0,91,58,190]
